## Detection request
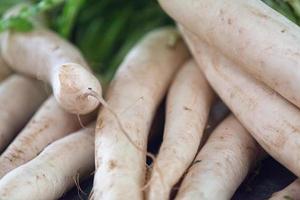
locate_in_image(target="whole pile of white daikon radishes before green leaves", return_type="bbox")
[0,0,300,200]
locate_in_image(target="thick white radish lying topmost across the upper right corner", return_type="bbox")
[159,0,300,107]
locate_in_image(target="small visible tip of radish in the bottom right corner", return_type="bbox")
[270,179,300,200]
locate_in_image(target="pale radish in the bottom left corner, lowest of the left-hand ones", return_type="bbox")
[0,126,94,200]
